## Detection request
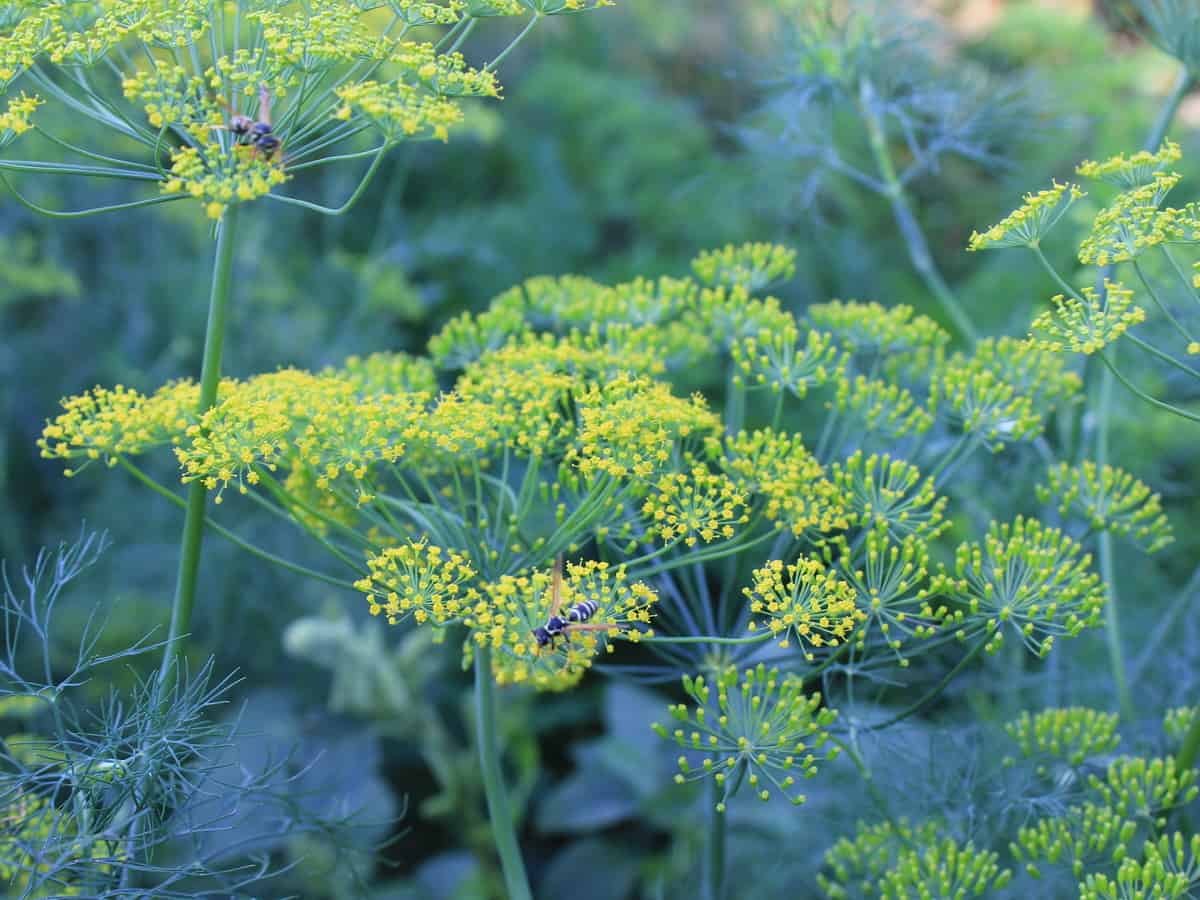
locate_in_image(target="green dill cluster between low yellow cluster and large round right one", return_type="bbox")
[826,527,947,668]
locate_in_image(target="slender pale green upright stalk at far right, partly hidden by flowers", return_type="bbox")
[1096,68,1200,724]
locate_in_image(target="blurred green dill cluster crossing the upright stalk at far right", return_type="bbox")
[1037,461,1175,553]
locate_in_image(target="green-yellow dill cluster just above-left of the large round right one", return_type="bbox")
[829,450,949,540]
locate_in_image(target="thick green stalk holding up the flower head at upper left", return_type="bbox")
[158,205,238,683]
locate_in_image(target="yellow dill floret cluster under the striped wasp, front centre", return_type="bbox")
[464,559,658,690]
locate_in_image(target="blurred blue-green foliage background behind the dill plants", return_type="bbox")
[0,0,1200,900]
